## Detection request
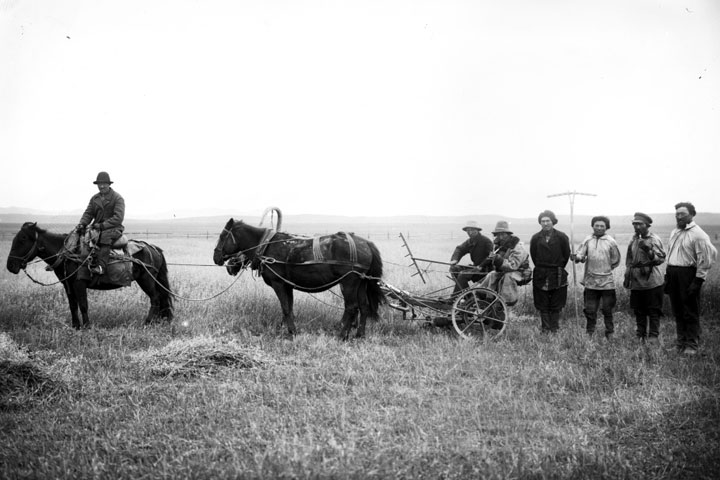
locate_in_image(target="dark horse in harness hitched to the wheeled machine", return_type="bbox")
[213,216,385,340]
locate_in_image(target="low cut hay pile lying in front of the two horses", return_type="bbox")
[134,336,266,377]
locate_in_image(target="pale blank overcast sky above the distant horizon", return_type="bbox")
[0,0,720,218]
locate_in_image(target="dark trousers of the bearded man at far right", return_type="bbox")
[665,265,700,349]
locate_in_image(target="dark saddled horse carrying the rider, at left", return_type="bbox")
[7,222,173,328]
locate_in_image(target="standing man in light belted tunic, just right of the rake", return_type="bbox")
[573,215,620,340]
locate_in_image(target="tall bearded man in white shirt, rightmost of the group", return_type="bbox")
[665,202,717,355]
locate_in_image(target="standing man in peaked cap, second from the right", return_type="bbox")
[623,212,665,344]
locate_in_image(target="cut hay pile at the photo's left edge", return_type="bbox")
[0,333,65,410]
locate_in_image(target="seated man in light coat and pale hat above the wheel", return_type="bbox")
[480,220,530,306]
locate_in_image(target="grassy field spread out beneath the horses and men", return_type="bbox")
[0,231,720,479]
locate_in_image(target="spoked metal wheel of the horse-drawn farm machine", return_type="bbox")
[452,288,508,340]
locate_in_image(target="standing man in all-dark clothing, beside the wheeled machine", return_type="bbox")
[530,210,570,333]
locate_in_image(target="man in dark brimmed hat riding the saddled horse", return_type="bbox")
[77,172,125,275]
